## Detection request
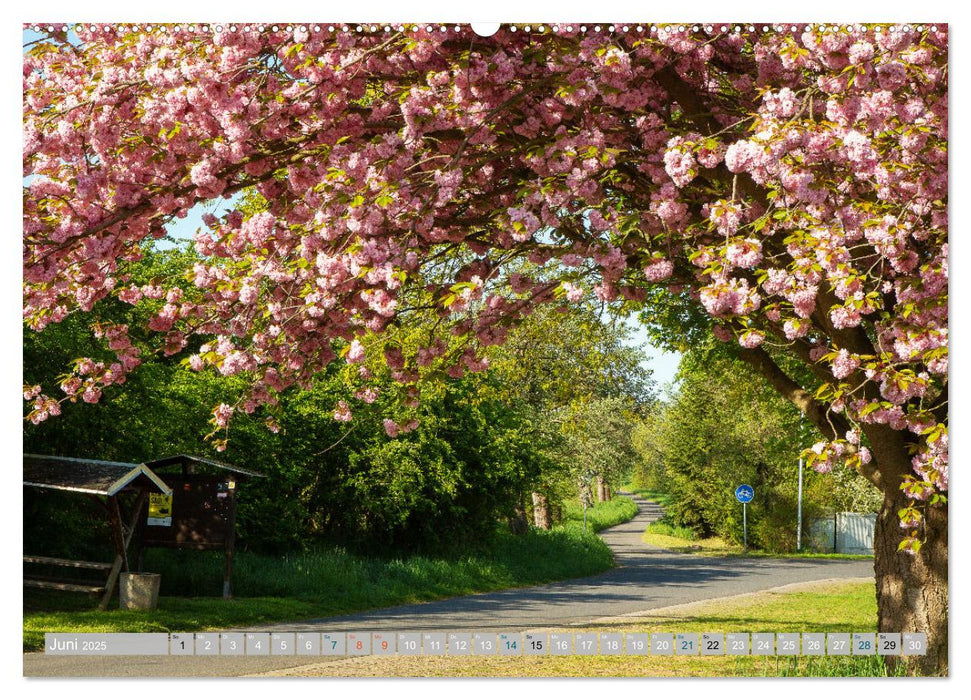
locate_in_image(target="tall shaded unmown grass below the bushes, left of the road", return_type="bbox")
[135,526,613,609]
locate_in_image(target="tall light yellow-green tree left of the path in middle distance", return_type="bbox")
[478,304,654,526]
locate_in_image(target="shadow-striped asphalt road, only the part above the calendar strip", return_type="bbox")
[247,494,873,632]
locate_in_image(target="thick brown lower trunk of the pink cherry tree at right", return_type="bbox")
[873,490,948,676]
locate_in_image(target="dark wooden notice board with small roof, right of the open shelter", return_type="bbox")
[138,455,265,598]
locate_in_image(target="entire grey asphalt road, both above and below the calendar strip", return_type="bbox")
[24,494,873,677]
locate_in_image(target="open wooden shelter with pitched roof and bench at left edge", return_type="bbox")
[24,454,172,610]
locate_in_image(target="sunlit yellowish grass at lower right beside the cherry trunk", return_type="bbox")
[264,582,912,677]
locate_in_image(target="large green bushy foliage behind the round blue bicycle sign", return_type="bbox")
[633,340,876,552]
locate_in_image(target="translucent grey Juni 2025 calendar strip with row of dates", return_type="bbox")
[44,631,927,657]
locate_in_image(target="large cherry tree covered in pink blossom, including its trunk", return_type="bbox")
[23,24,948,672]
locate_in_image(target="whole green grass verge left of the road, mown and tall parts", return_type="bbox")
[23,499,636,651]
